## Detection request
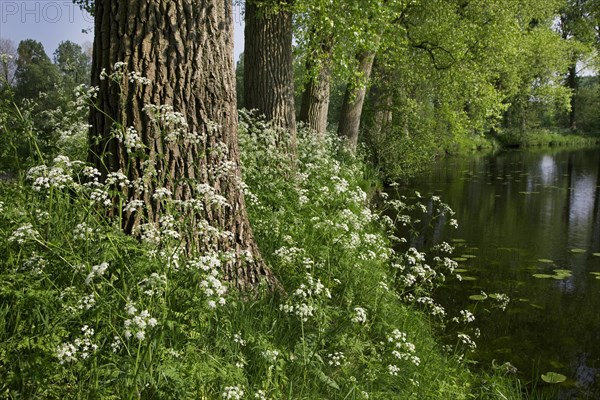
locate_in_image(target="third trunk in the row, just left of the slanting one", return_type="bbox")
[299,44,332,136]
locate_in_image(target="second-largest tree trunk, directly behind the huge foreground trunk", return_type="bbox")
[244,0,296,148]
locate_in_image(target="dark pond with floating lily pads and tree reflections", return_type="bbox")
[403,149,600,399]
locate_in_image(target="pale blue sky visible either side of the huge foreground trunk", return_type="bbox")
[0,0,244,61]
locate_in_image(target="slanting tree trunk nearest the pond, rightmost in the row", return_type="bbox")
[338,52,375,150]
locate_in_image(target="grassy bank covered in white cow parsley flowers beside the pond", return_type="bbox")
[0,111,520,399]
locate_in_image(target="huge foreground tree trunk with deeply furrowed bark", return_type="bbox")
[89,0,275,288]
